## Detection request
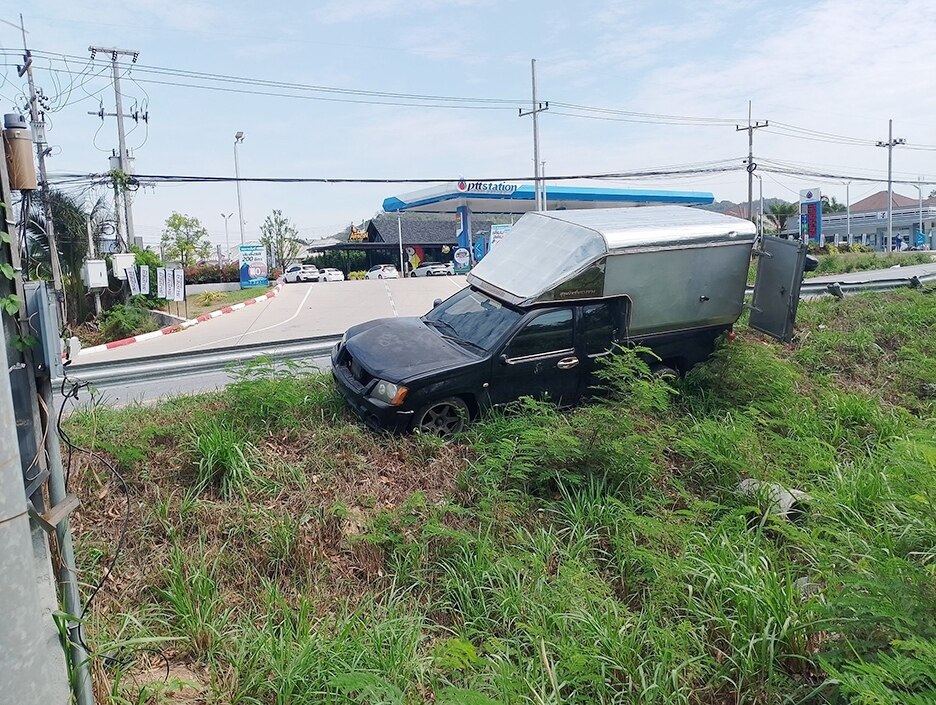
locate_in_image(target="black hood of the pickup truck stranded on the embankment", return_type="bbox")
[345,318,478,382]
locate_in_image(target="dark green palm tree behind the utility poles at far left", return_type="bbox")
[27,191,114,323]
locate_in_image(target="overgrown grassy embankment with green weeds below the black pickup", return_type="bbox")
[62,290,936,705]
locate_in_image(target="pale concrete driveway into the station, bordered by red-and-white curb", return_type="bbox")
[75,276,466,368]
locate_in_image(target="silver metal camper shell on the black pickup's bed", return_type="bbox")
[468,206,805,337]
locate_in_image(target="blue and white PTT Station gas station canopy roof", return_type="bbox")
[383,179,715,214]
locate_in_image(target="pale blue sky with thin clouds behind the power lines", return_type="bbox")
[0,0,936,250]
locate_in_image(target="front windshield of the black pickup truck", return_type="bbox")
[423,288,523,350]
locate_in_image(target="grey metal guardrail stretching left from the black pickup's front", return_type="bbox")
[56,335,341,384]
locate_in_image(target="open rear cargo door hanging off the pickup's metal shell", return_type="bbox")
[750,236,806,343]
